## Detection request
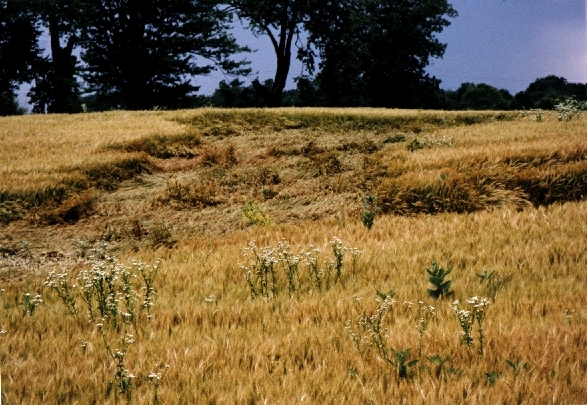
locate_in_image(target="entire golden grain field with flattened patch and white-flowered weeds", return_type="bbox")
[0,109,587,404]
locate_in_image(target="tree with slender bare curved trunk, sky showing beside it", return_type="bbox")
[227,0,314,107]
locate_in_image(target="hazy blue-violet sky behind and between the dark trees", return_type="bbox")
[197,0,587,93]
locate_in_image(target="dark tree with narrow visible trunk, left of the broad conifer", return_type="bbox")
[29,0,87,113]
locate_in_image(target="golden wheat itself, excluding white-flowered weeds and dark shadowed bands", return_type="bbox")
[0,109,587,404]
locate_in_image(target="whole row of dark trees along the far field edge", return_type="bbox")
[0,0,585,115]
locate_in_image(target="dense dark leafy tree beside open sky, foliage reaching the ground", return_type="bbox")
[309,0,457,107]
